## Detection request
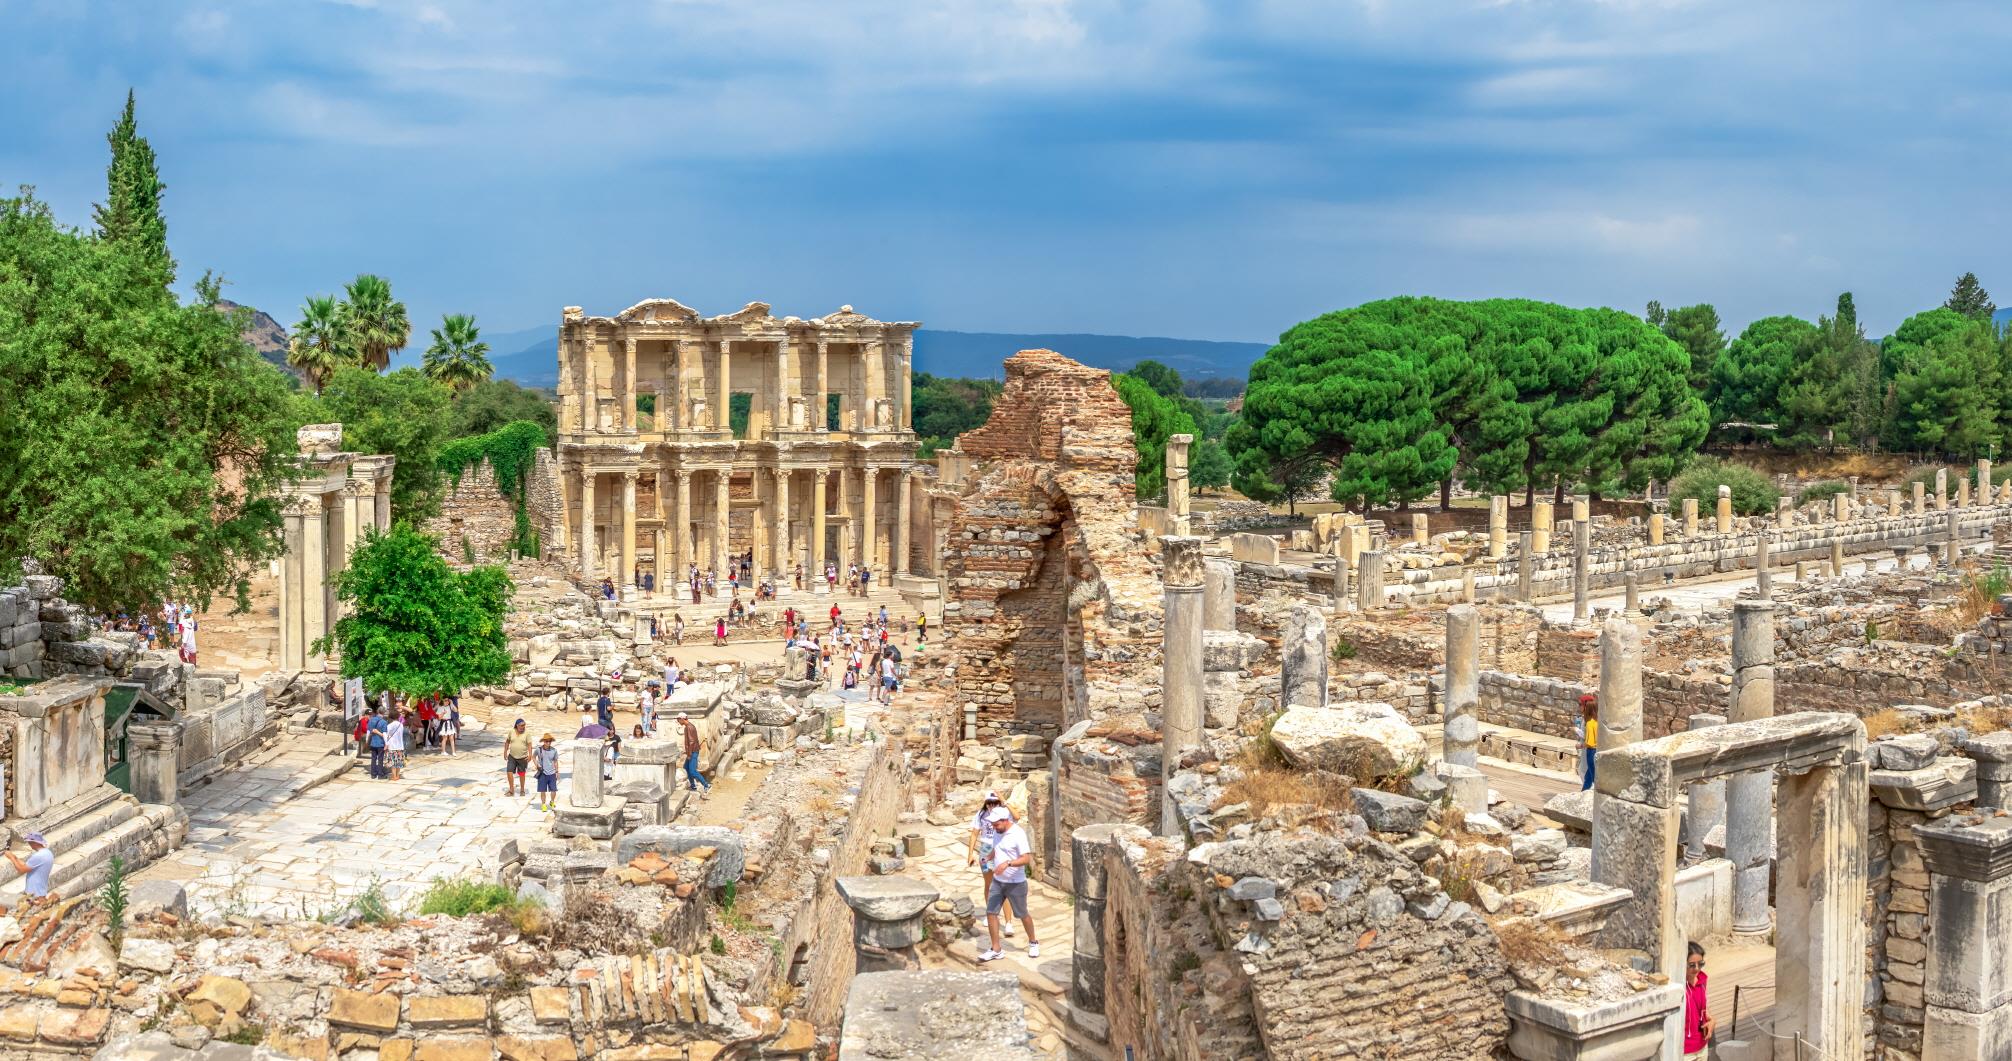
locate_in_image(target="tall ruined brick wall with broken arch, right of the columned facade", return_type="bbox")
[944,350,1161,741]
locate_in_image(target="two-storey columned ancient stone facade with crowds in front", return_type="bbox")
[551,298,928,586]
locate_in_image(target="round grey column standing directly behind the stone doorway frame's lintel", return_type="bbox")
[1722,600,1770,934]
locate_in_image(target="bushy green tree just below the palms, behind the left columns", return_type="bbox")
[316,366,451,523]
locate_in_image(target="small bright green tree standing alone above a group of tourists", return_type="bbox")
[314,525,513,697]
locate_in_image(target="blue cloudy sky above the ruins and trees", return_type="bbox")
[0,0,2012,348]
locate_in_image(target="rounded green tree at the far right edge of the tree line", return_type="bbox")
[1881,308,2004,457]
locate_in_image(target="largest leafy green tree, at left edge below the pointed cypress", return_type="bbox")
[0,193,296,612]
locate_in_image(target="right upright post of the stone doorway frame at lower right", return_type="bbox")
[1778,759,1867,1061]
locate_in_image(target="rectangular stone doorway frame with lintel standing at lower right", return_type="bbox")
[1594,711,1871,1061]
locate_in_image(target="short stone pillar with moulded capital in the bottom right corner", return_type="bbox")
[1913,815,2012,1061]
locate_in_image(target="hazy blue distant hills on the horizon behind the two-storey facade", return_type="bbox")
[483,328,1270,387]
